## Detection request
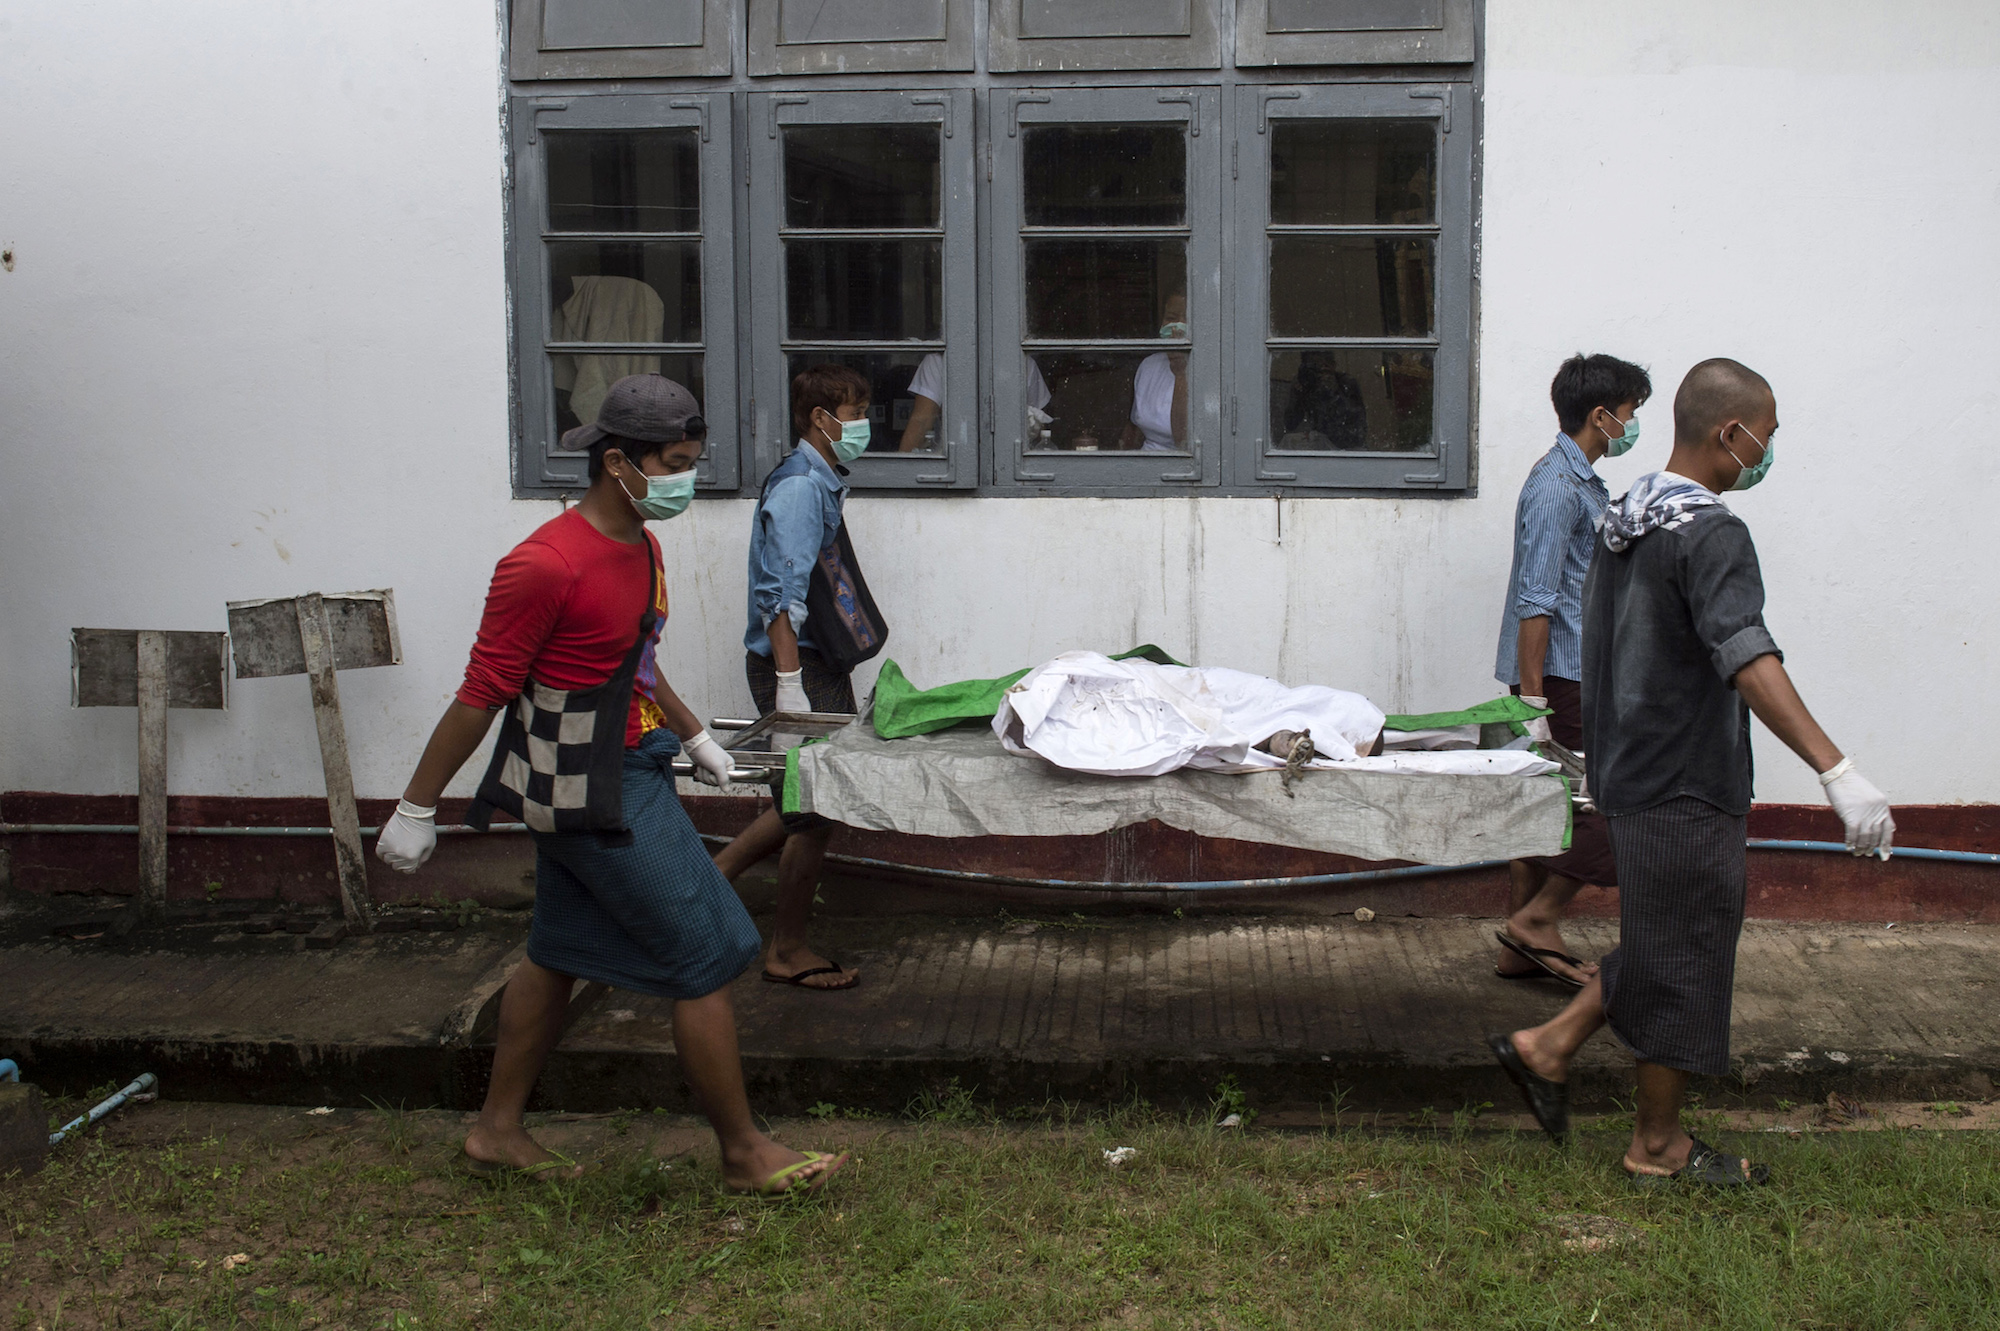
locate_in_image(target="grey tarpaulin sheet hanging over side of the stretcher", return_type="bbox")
[798,723,1570,863]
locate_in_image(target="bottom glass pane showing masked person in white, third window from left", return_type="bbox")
[1028,350,1188,454]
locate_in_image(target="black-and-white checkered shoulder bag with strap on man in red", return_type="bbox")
[466,540,660,845]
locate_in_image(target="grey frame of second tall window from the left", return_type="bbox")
[746,88,982,490]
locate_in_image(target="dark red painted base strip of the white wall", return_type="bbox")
[0,791,2000,923]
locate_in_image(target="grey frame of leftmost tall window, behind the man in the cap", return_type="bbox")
[508,92,742,498]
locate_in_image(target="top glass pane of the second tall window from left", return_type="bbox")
[784,124,944,228]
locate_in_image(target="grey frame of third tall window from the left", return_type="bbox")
[980,84,1230,494]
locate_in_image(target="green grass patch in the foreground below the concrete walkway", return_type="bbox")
[0,1089,2000,1331]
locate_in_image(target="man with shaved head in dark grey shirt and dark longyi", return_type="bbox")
[1488,360,1896,1185]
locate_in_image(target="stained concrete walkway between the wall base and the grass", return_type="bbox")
[0,915,2000,1113]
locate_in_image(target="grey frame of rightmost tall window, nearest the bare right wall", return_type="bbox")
[1232,82,1476,492]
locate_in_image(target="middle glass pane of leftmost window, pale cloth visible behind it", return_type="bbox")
[548,240,702,342]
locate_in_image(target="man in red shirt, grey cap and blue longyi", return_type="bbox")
[376,374,846,1193]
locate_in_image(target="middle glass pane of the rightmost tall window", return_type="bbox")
[1270,232,1438,338]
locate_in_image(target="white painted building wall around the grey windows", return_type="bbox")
[0,0,2000,803]
